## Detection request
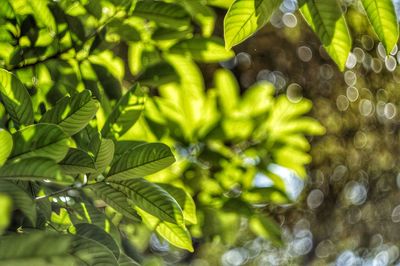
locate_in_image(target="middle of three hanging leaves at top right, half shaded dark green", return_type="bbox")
[300,0,352,71]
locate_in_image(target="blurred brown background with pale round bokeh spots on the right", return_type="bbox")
[144,1,400,266]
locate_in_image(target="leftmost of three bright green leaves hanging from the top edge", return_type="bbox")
[224,0,282,49]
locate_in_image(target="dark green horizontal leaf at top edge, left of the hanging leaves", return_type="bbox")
[132,1,190,28]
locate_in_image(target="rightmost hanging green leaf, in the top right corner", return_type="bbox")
[361,0,399,54]
